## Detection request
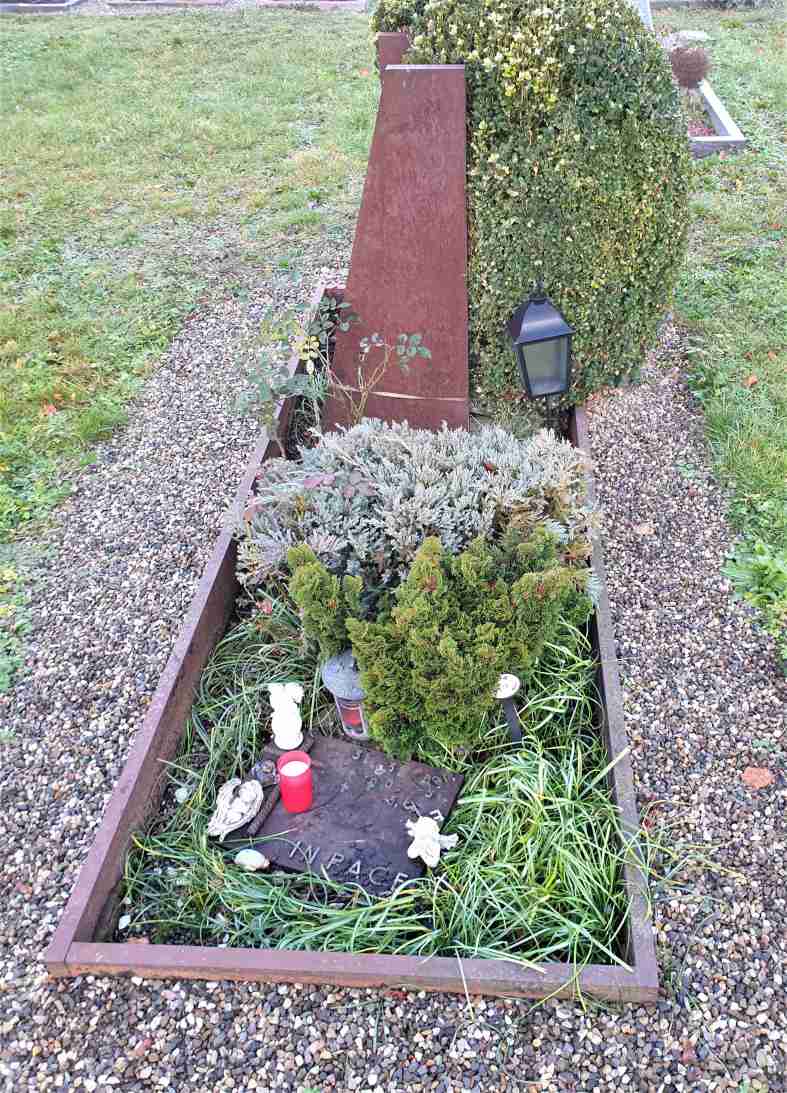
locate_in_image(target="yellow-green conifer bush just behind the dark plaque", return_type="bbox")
[290,528,591,759]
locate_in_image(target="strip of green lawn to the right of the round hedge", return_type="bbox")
[658,10,787,657]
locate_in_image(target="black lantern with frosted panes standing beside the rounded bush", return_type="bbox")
[508,285,574,419]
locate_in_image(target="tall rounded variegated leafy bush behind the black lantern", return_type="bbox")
[374,0,690,402]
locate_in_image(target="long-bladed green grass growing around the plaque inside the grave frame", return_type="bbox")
[122,612,631,965]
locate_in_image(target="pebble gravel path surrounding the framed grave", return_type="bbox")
[0,319,787,1093]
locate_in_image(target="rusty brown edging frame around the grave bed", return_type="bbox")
[44,286,658,1002]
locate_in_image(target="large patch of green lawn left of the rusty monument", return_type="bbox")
[0,12,378,693]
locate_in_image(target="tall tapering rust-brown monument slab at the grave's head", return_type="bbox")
[326,42,469,428]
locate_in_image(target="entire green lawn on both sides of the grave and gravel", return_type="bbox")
[0,11,787,686]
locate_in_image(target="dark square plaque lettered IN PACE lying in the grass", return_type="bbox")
[244,736,463,895]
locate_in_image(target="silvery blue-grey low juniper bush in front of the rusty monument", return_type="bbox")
[238,421,594,606]
